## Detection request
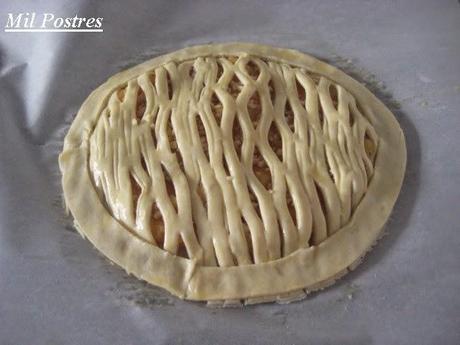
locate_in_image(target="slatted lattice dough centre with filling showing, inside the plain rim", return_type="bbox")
[89,56,378,266]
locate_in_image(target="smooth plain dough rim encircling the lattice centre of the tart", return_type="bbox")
[59,43,406,301]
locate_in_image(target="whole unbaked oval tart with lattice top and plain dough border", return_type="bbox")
[59,43,406,302]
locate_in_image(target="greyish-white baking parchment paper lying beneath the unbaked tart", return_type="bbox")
[0,0,460,344]
